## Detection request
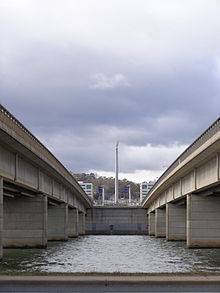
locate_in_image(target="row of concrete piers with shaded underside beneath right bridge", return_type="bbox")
[148,187,220,248]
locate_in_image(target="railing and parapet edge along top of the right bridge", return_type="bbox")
[144,117,220,201]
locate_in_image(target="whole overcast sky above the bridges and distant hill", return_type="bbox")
[0,0,220,182]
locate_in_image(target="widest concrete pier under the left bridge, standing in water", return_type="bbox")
[3,194,47,248]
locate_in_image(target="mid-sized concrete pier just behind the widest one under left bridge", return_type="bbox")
[48,203,68,241]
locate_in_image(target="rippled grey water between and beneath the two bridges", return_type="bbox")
[0,236,220,272]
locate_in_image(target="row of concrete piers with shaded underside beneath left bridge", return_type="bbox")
[0,178,85,257]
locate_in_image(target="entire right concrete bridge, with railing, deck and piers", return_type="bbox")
[142,118,220,248]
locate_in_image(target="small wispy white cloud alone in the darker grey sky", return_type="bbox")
[90,73,130,89]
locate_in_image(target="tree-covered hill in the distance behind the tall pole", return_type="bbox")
[72,173,140,199]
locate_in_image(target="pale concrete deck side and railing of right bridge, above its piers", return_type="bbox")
[142,118,220,210]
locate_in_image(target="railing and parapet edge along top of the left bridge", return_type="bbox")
[0,104,91,205]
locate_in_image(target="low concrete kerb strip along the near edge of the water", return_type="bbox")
[0,272,220,285]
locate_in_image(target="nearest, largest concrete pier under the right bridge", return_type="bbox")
[187,194,220,248]
